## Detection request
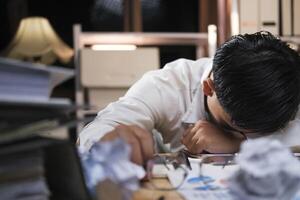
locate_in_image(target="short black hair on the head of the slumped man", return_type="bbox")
[213,31,300,134]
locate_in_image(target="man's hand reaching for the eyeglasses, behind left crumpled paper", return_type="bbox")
[100,125,154,165]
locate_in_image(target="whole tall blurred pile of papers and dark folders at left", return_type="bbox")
[0,58,90,200]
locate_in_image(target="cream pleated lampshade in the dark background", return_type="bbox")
[4,17,73,64]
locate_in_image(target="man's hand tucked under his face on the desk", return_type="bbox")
[181,120,243,154]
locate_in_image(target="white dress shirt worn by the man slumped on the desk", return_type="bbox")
[79,58,300,150]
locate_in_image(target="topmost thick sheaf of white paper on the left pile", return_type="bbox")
[0,58,74,100]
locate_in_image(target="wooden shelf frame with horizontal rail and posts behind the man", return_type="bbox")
[73,24,216,131]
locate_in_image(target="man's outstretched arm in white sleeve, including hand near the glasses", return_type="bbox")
[79,73,165,164]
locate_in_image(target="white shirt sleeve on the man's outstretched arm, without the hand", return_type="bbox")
[79,70,173,149]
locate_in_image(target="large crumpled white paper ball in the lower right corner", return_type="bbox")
[228,138,300,200]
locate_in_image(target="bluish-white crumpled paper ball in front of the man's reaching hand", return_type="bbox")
[78,138,145,199]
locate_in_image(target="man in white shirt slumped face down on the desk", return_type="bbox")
[79,32,300,165]
